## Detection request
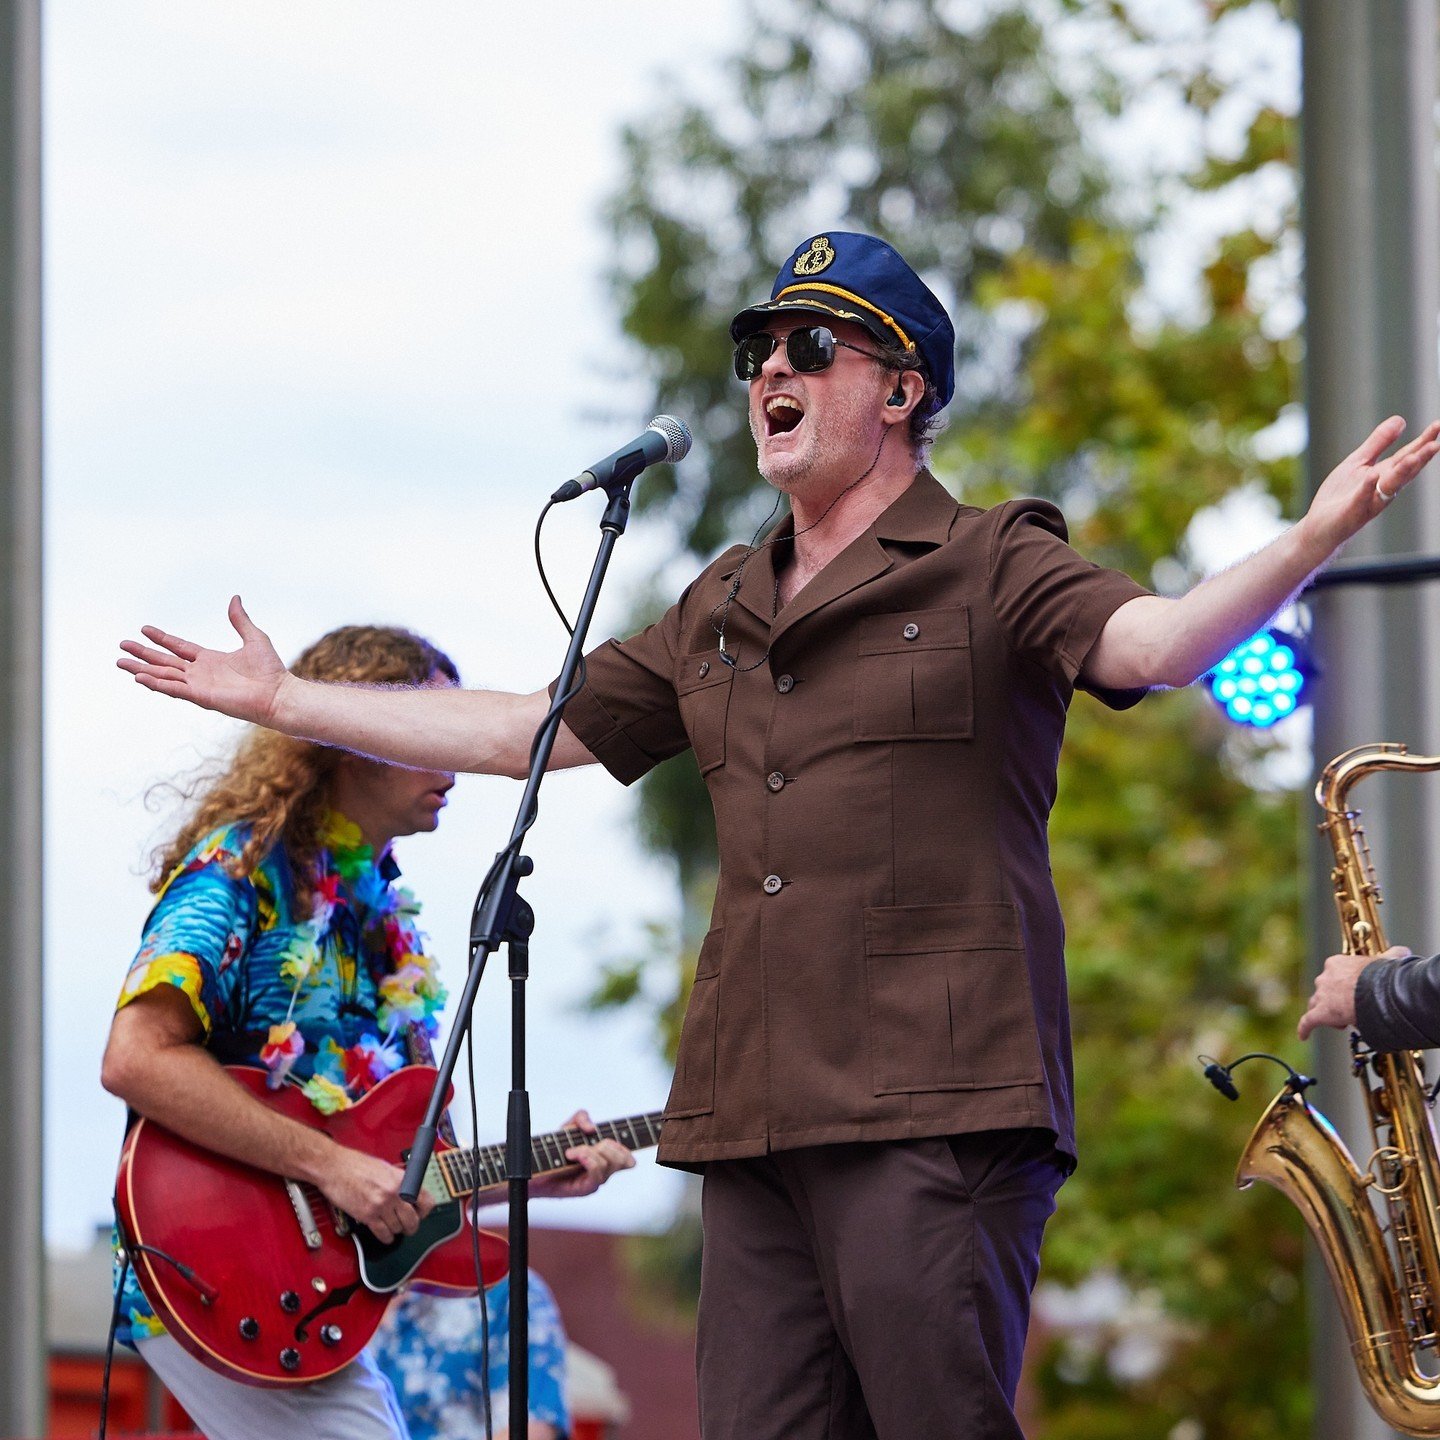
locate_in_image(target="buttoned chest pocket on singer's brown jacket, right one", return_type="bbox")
[855,605,975,740]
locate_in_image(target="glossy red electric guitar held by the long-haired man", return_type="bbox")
[115,1066,661,1385]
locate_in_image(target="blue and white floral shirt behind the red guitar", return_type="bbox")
[369,1270,570,1440]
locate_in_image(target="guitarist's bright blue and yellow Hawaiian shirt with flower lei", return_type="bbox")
[117,815,444,1345]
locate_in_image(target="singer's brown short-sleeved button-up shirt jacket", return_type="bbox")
[566,471,1148,1166]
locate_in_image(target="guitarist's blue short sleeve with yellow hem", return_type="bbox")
[115,831,255,1035]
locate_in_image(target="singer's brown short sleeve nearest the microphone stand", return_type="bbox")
[550,598,690,785]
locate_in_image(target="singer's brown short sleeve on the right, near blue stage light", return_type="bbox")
[989,500,1152,710]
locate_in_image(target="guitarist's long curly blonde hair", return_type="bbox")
[150,625,459,913]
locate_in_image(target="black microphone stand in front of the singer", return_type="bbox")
[400,475,645,1440]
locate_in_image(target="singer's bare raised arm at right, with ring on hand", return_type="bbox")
[1081,416,1440,690]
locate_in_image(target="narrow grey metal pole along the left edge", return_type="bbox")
[0,0,46,1436]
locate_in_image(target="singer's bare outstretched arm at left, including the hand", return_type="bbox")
[117,595,595,778]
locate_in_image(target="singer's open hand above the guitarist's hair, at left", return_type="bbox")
[115,595,289,724]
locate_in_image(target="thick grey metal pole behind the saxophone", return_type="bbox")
[1300,0,1440,1440]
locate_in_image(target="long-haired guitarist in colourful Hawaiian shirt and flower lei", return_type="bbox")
[101,625,634,1440]
